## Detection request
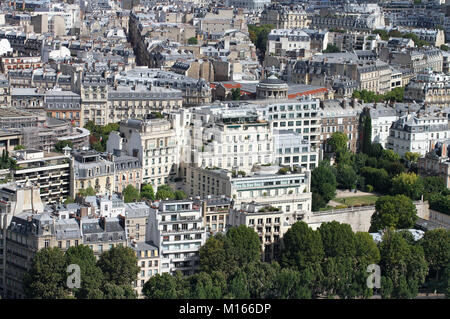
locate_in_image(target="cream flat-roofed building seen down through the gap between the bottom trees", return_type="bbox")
[229,203,303,262]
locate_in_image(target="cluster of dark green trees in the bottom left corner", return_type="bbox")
[23,245,140,299]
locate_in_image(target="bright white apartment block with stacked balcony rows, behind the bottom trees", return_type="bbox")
[149,200,206,275]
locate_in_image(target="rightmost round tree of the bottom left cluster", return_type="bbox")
[97,246,140,286]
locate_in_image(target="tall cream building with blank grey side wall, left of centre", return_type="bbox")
[107,118,179,186]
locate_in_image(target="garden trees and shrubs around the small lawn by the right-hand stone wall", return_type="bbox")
[311,131,450,231]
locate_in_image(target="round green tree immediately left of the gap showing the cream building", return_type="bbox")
[224,225,261,267]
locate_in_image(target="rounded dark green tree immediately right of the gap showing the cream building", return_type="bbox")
[281,221,325,271]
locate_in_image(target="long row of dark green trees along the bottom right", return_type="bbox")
[143,221,450,299]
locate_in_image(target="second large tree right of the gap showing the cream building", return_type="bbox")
[318,221,356,258]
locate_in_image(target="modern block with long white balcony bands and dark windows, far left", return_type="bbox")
[11,149,72,204]
